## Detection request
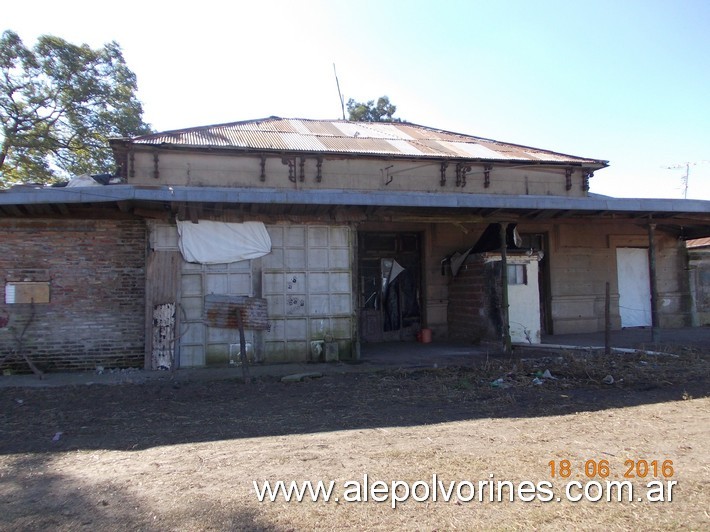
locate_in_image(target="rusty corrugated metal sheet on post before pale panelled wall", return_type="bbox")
[205,294,269,331]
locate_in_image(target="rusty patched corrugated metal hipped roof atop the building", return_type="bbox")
[130,117,607,166]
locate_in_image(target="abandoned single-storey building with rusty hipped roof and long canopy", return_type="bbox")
[0,117,710,370]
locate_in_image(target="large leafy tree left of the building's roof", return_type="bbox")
[0,30,150,186]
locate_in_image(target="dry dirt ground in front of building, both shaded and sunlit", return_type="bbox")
[0,342,710,530]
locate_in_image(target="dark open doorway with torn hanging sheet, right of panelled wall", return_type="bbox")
[358,232,422,342]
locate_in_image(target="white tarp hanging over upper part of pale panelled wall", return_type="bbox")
[177,220,271,264]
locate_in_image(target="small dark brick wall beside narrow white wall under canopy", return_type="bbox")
[448,257,502,343]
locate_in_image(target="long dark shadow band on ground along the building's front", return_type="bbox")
[0,340,710,454]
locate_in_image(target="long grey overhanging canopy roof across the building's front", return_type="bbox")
[0,185,710,238]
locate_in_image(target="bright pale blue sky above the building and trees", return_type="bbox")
[0,0,710,199]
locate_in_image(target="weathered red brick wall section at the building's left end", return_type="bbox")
[0,218,146,371]
